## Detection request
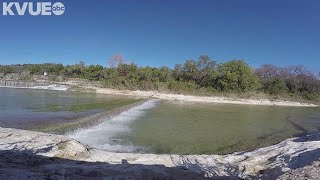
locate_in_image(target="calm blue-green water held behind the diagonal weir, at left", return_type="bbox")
[0,88,140,130]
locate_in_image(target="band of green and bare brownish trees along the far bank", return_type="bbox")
[0,56,320,100]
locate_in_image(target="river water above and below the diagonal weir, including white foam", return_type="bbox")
[0,88,320,154]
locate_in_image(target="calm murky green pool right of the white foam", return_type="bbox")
[119,102,320,154]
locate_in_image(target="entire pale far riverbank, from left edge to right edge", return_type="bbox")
[0,81,319,107]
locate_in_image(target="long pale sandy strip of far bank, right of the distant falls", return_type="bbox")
[88,87,318,107]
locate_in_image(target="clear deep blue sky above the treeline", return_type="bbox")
[0,0,320,71]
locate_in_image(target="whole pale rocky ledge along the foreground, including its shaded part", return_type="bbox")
[0,128,320,179]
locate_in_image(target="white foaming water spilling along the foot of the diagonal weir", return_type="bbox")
[68,100,159,152]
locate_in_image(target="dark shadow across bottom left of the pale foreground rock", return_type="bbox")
[0,150,230,180]
